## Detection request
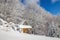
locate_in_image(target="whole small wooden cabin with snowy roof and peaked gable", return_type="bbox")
[19,20,32,33]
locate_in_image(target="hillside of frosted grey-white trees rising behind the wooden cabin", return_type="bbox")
[0,0,60,38]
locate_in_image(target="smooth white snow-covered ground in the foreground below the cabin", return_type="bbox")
[0,30,60,40]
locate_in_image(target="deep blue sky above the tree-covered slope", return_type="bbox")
[22,0,60,15]
